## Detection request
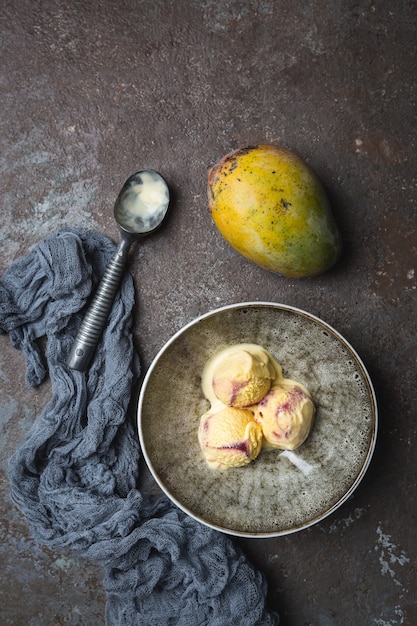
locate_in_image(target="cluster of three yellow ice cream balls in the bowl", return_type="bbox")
[198,343,315,469]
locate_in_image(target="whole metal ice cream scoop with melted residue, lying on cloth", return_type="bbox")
[67,170,169,371]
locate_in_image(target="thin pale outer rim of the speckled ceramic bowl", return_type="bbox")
[137,300,379,539]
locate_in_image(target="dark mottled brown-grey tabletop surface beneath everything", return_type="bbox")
[0,0,417,626]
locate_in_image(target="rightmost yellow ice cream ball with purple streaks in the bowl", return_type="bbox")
[254,379,315,450]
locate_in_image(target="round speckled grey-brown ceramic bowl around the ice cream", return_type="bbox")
[138,302,377,537]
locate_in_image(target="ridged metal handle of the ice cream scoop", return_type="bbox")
[67,239,132,372]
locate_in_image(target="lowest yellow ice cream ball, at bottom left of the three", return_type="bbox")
[198,407,262,469]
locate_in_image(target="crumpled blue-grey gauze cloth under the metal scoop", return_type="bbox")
[0,228,278,626]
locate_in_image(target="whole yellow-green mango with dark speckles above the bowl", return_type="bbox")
[208,144,342,278]
